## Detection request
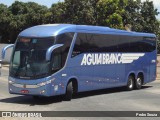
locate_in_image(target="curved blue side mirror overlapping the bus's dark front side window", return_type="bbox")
[46,44,64,61]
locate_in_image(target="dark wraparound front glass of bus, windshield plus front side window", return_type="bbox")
[10,33,74,79]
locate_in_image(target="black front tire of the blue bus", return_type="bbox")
[65,82,73,101]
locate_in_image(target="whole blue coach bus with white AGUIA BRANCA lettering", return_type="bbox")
[2,24,157,100]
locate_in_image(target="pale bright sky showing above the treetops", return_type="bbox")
[0,0,160,20]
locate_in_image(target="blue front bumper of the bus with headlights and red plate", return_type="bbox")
[8,77,60,97]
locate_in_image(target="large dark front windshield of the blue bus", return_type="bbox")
[10,37,55,79]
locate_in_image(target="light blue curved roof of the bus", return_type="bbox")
[19,24,156,37]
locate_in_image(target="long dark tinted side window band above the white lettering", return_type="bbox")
[72,33,156,57]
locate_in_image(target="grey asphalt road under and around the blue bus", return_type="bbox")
[0,67,160,120]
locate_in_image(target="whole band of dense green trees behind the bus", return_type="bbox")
[0,0,160,46]
